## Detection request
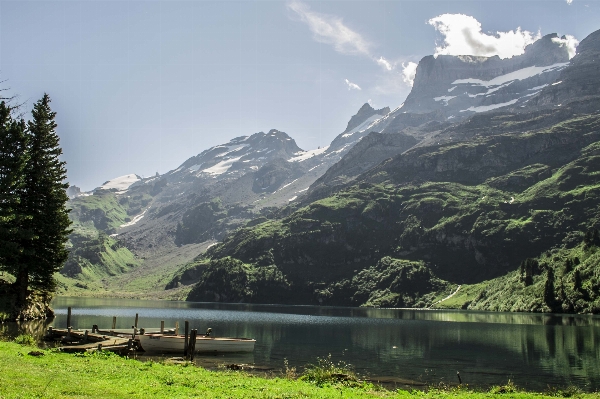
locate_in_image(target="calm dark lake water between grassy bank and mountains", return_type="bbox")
[4,297,600,391]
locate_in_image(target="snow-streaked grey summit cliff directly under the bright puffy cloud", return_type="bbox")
[402,34,569,118]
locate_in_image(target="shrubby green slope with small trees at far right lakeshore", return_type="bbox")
[435,234,600,313]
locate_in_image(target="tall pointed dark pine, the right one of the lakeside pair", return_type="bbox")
[15,94,71,305]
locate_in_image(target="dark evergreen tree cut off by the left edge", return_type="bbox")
[0,101,30,275]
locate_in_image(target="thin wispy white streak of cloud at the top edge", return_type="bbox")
[287,0,371,56]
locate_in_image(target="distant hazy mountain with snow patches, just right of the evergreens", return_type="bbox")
[61,108,389,298]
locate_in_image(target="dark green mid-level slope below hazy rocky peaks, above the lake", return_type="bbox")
[174,114,600,311]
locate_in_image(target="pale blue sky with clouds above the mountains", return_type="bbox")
[0,0,600,190]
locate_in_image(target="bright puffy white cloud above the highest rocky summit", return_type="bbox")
[428,14,541,58]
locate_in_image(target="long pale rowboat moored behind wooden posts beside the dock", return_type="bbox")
[136,333,256,353]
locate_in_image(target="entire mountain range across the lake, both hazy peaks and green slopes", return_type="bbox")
[63,27,600,312]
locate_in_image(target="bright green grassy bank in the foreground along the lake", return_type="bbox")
[0,342,600,399]
